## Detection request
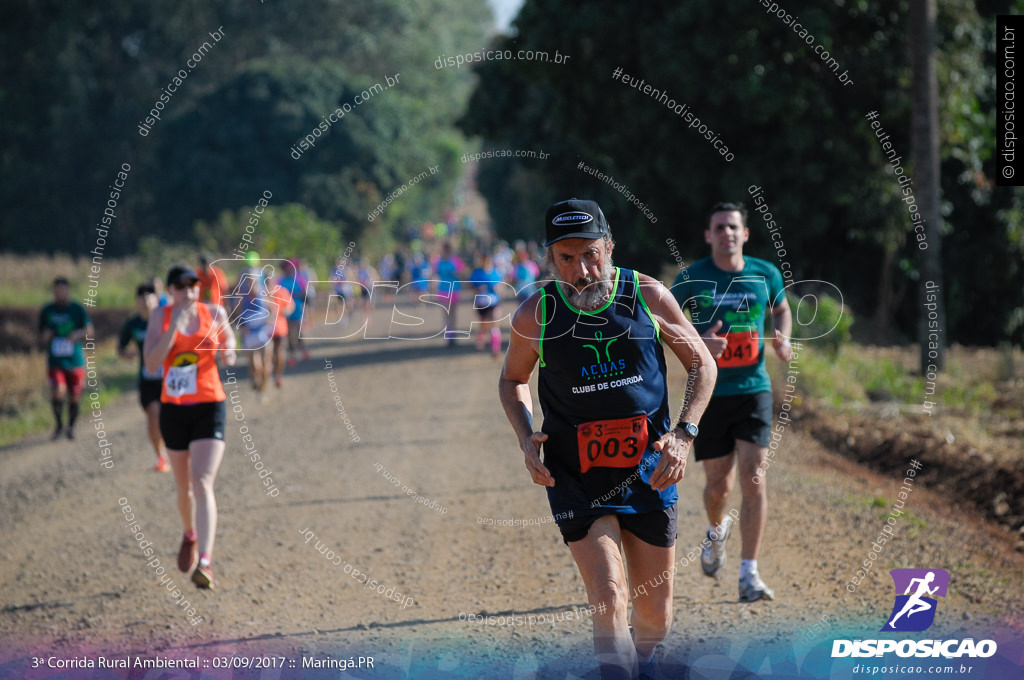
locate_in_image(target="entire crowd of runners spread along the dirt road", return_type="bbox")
[39,199,793,678]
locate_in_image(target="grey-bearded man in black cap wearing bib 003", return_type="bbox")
[499,199,717,678]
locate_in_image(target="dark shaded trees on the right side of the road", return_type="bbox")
[460,0,1024,343]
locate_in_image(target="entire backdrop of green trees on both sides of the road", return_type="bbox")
[0,0,1024,345]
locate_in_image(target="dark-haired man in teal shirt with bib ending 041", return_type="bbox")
[672,203,793,602]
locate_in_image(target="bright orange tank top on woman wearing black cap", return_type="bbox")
[160,302,225,406]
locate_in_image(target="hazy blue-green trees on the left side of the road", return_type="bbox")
[0,0,490,256]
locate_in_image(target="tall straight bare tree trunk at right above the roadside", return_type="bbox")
[910,0,946,375]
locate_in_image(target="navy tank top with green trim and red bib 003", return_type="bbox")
[538,268,678,517]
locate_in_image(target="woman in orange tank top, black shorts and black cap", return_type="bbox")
[144,266,234,588]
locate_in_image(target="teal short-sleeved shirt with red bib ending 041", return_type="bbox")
[672,255,785,396]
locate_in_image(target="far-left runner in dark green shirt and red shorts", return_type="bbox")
[39,277,93,439]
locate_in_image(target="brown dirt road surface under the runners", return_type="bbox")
[0,303,1024,680]
